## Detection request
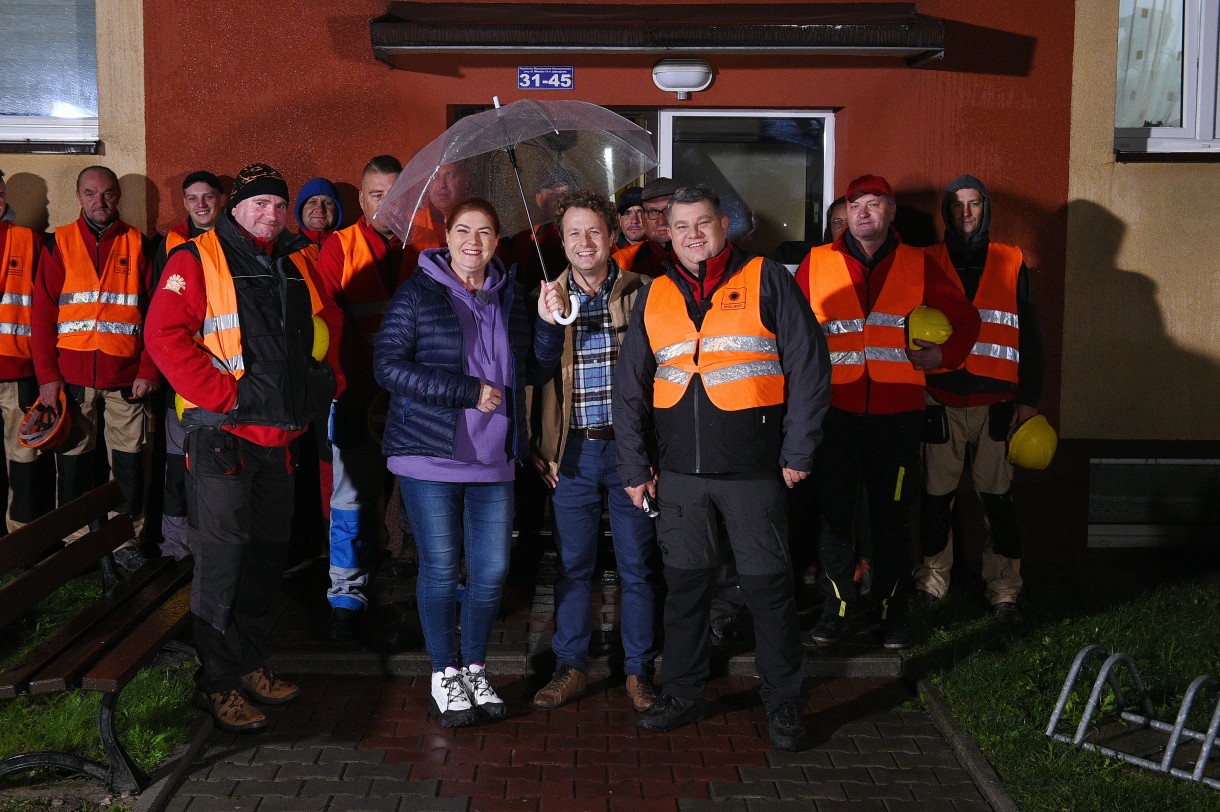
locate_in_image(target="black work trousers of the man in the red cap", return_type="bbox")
[814,408,924,619]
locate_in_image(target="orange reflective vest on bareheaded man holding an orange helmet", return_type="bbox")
[55,223,144,358]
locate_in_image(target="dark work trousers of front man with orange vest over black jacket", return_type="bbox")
[658,471,805,707]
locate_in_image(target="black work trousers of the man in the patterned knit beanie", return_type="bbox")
[185,429,294,693]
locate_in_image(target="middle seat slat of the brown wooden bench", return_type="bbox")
[29,566,190,694]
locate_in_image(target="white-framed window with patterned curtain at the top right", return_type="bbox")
[1114,0,1220,152]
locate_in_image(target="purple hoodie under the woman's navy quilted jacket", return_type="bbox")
[389,249,516,482]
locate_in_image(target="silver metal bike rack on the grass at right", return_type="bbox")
[1047,645,1220,790]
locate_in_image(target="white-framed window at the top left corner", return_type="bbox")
[0,0,98,151]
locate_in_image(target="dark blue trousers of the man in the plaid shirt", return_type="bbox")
[550,433,658,675]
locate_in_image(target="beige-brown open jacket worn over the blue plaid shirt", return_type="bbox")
[526,260,651,474]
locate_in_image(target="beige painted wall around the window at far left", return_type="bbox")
[0,0,149,230]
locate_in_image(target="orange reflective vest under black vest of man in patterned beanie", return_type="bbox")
[185,230,322,408]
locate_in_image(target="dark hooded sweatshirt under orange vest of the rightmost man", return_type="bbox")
[927,174,1044,408]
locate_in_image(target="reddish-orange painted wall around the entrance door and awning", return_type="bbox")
[144,0,1072,416]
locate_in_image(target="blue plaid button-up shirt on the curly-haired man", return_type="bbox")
[567,266,619,429]
